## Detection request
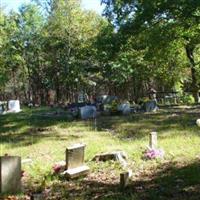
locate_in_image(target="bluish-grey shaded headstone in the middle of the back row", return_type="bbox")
[80,106,97,119]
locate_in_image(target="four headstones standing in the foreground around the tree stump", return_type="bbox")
[0,132,157,194]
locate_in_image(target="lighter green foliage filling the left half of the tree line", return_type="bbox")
[0,0,105,101]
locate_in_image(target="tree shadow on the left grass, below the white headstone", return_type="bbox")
[0,109,75,147]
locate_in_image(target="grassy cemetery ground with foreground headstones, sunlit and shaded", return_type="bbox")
[0,106,200,200]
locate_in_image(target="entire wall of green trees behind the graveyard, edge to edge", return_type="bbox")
[0,0,200,104]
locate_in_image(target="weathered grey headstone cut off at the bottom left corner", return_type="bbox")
[0,156,21,194]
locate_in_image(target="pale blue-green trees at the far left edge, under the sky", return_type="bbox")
[0,4,43,101]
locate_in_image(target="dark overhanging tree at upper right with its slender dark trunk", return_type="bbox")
[102,0,200,102]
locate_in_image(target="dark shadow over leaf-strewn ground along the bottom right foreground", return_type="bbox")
[46,161,200,200]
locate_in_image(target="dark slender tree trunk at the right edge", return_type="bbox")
[185,45,199,103]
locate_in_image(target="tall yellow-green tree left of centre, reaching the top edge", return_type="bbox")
[43,0,106,100]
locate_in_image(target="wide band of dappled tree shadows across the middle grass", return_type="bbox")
[0,107,200,146]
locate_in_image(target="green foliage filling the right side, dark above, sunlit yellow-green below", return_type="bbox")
[102,0,200,101]
